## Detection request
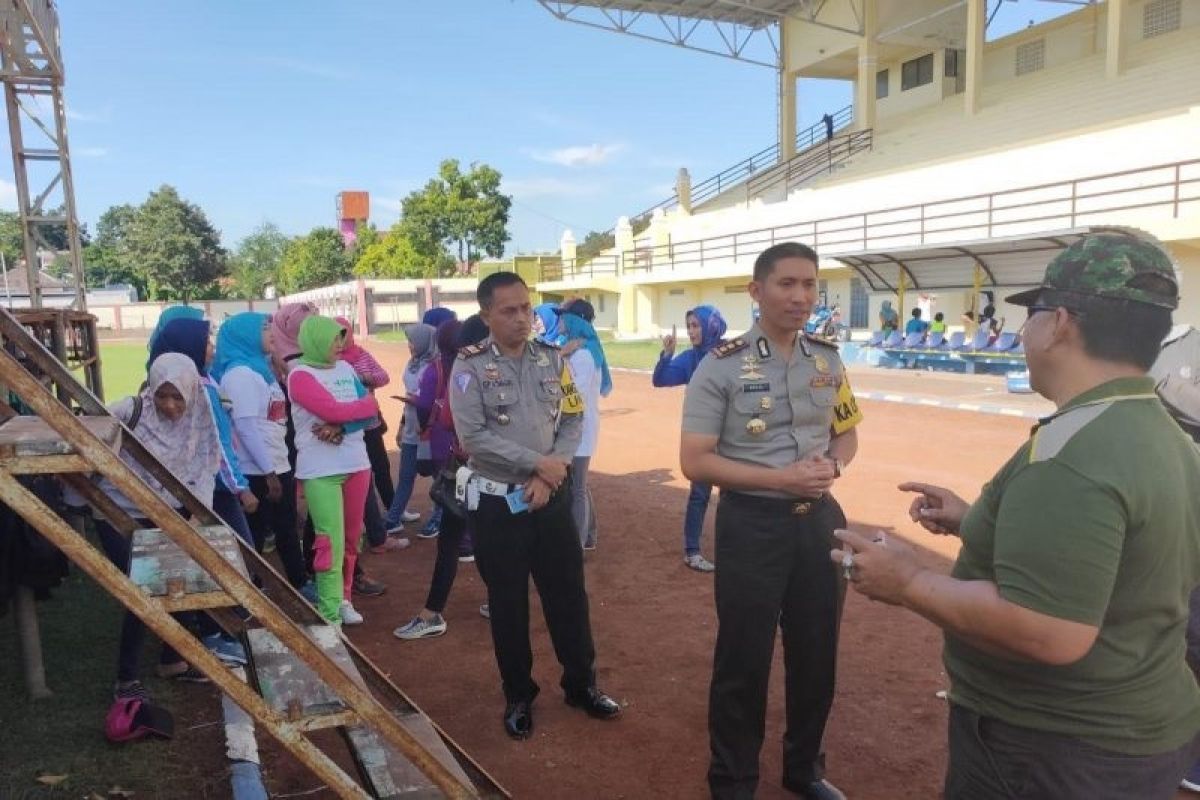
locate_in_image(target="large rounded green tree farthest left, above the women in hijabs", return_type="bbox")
[120,185,227,302]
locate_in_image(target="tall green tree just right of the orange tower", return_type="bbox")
[401,158,512,271]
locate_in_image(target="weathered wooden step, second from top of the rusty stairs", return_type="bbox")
[130,525,246,599]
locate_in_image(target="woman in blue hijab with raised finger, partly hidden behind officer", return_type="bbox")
[650,306,726,572]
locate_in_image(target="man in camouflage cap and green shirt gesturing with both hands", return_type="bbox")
[830,227,1200,800]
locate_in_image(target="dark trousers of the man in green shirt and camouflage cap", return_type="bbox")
[946,704,1200,800]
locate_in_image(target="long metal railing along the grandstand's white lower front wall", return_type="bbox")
[542,158,1200,279]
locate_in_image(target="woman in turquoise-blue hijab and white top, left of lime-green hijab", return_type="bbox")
[210,311,313,597]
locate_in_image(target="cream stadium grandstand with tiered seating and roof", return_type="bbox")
[536,0,1200,338]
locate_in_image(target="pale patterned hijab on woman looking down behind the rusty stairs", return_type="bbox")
[130,353,221,504]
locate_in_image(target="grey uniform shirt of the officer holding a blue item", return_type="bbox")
[449,338,583,483]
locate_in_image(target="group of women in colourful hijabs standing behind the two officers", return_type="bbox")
[92,292,725,714]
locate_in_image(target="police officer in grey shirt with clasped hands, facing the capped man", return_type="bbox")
[679,242,862,800]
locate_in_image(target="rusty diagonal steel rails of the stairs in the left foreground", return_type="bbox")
[0,304,508,799]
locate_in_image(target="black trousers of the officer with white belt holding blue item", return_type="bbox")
[470,481,595,702]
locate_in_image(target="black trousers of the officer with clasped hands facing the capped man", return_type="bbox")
[708,492,846,800]
